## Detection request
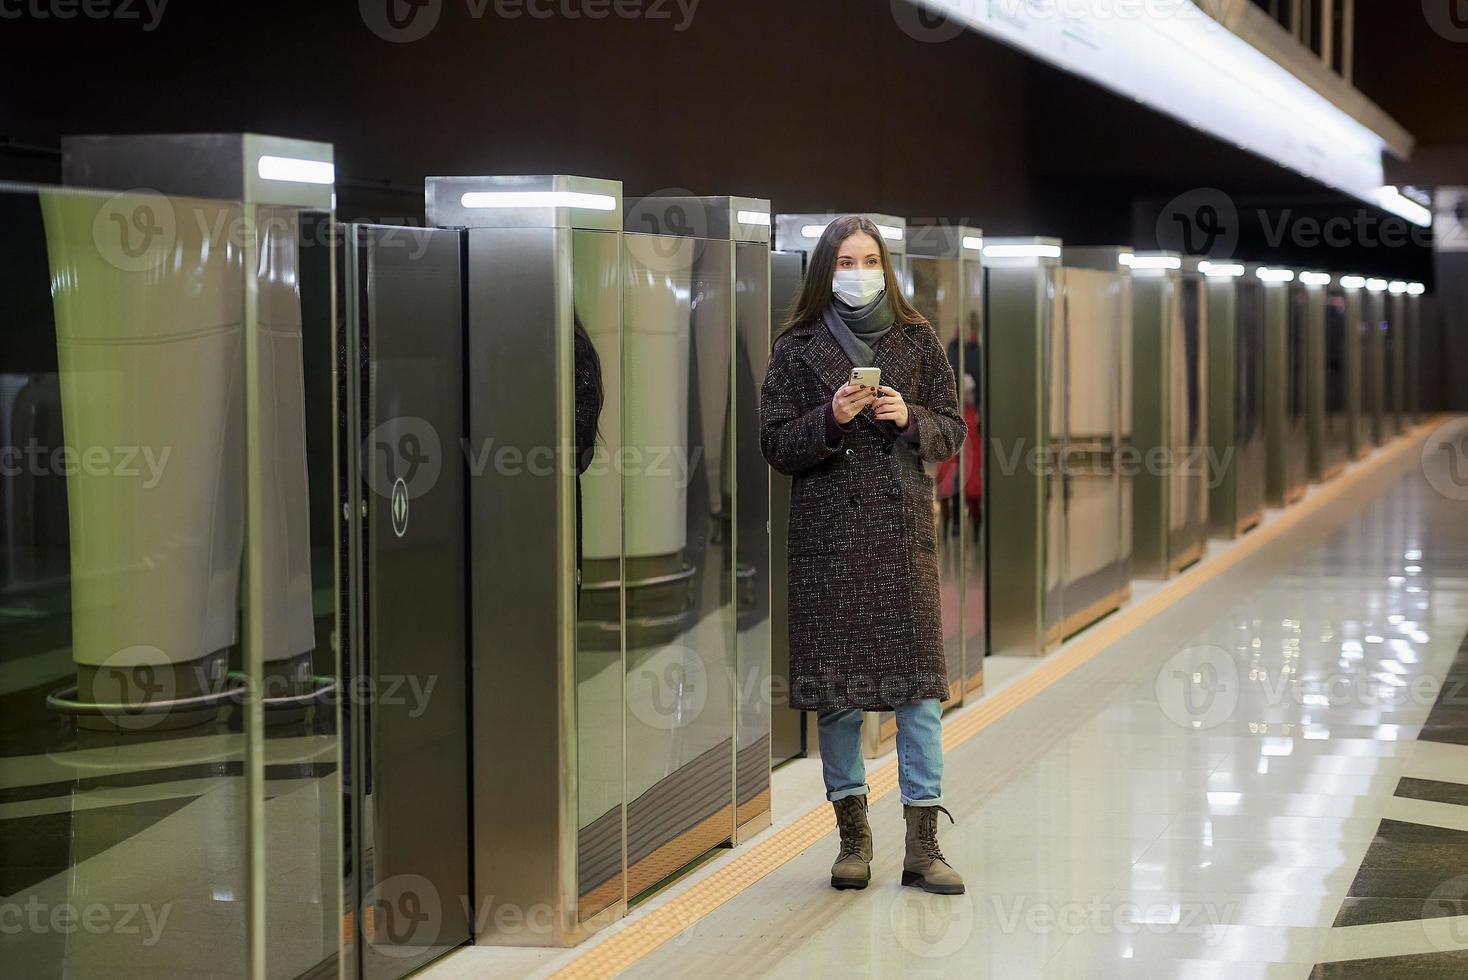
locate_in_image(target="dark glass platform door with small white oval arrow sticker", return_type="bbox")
[331,218,470,977]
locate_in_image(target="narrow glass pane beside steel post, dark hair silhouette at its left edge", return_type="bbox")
[571,230,625,920]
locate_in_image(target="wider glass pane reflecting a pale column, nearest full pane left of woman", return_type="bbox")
[622,235,734,896]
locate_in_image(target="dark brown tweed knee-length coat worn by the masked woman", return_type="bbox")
[759,321,966,712]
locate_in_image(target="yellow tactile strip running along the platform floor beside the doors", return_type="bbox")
[552,415,1447,979]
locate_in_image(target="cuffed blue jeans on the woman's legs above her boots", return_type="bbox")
[816,698,942,807]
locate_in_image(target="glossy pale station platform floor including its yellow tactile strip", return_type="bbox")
[420,418,1468,980]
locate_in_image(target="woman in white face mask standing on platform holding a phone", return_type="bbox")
[759,216,964,893]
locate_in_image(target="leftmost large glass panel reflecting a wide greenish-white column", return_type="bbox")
[0,189,247,977]
